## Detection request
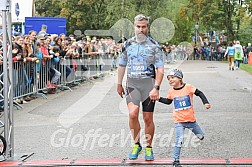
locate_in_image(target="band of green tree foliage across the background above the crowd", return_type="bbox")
[35,0,252,43]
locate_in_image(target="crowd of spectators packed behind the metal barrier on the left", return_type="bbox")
[0,30,121,104]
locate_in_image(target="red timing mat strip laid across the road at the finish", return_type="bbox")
[0,158,252,166]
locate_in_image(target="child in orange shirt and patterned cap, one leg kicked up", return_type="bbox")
[158,69,211,167]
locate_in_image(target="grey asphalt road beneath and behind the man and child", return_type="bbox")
[8,61,252,166]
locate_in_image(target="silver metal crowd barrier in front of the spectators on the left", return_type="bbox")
[8,53,112,108]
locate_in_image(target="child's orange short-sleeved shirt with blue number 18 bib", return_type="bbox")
[167,84,196,123]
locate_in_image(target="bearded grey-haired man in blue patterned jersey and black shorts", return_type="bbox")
[117,14,164,161]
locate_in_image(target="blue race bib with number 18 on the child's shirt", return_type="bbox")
[174,95,191,111]
